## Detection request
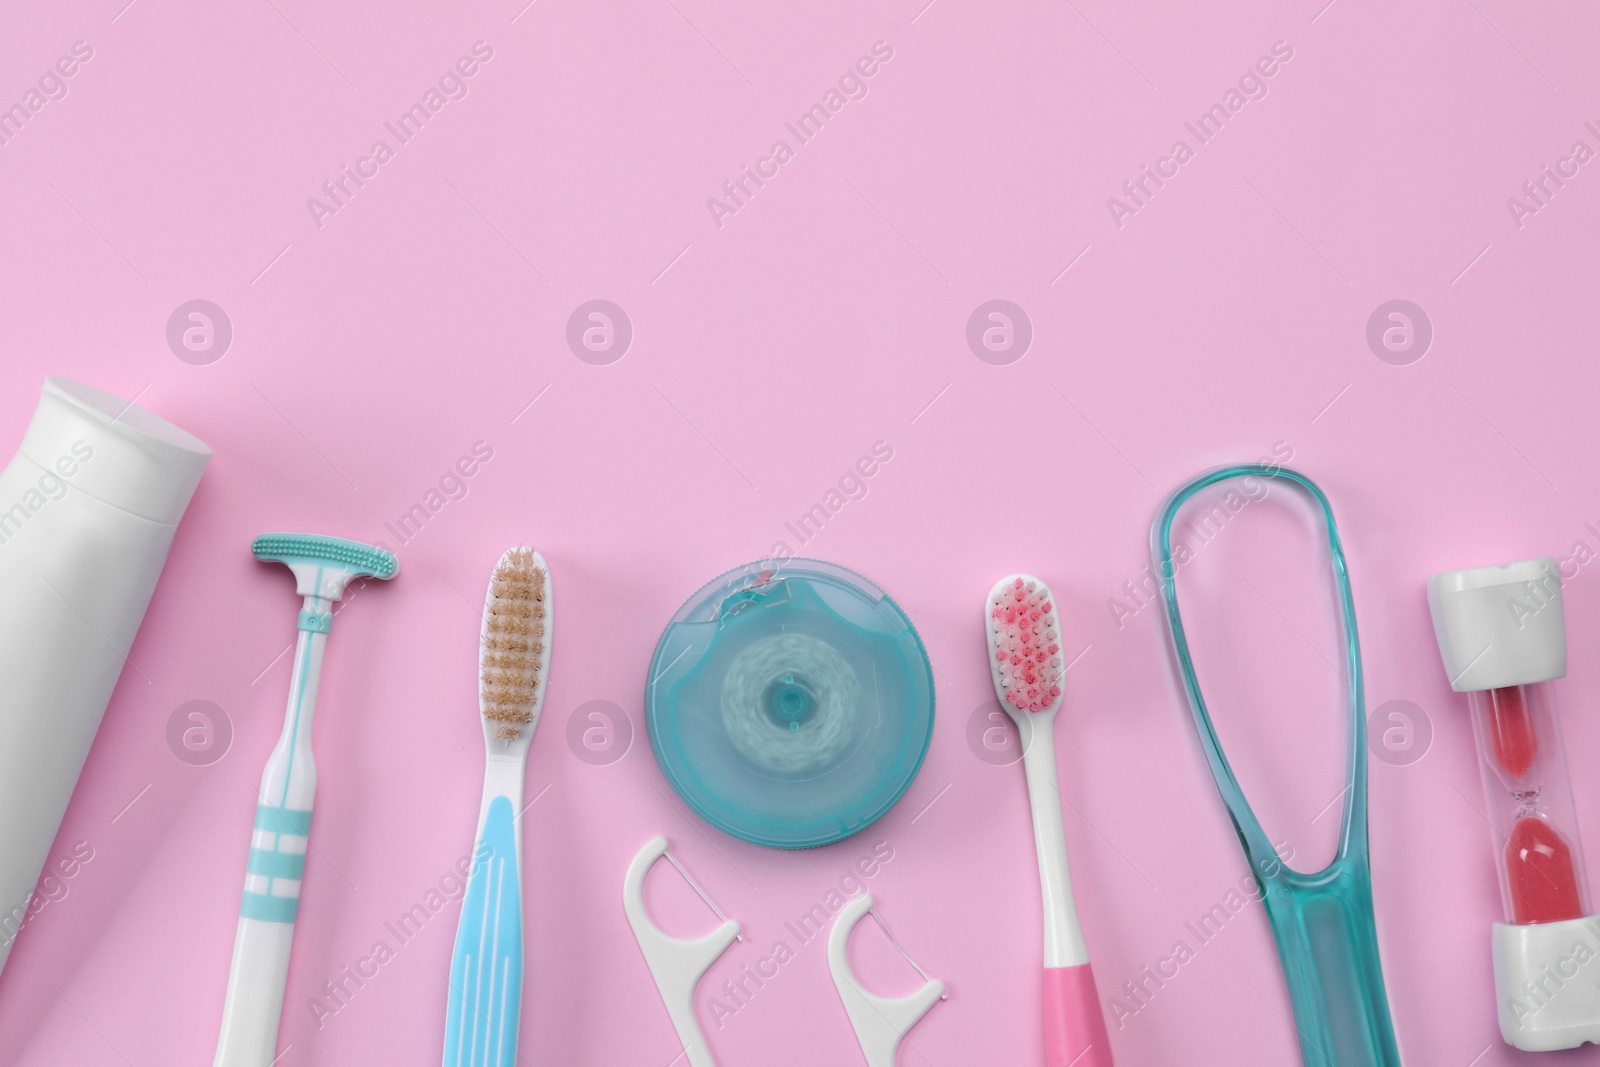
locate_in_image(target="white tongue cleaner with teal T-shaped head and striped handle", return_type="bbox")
[214,534,400,1067]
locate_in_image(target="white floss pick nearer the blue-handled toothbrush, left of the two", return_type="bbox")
[622,837,739,1067]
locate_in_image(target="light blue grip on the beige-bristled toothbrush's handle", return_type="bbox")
[445,797,522,1067]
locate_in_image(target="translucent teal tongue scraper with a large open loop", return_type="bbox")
[1150,464,1400,1067]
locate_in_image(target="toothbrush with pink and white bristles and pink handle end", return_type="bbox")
[984,574,1112,1067]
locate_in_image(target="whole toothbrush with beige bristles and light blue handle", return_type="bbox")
[445,545,554,1067]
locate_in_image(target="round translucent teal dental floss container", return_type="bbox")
[645,560,933,848]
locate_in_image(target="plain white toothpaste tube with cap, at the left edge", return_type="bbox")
[0,378,211,968]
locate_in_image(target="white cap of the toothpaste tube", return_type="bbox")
[19,378,211,525]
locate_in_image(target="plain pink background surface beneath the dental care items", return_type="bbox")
[0,0,1600,1067]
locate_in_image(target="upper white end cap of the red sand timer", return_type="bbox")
[1427,557,1566,693]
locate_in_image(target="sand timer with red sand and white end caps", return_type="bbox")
[1427,558,1600,1051]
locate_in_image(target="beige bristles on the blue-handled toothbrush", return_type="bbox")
[478,549,547,741]
